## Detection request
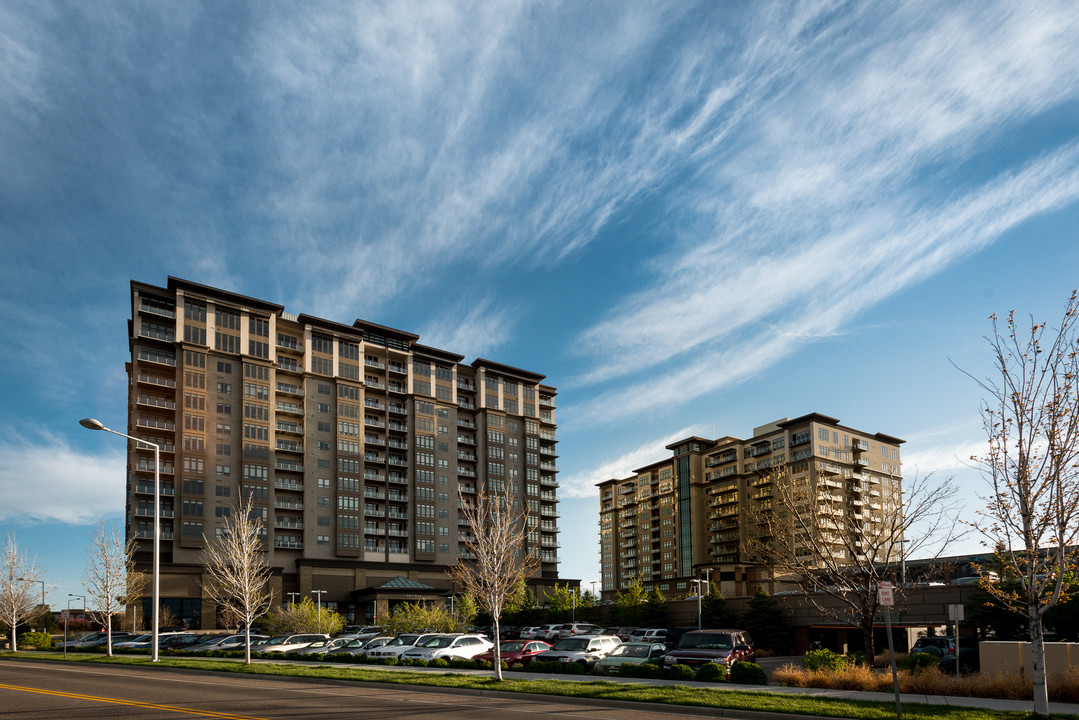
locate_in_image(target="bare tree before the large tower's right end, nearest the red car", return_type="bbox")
[450,484,538,680]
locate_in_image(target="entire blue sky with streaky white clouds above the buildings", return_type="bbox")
[0,0,1079,606]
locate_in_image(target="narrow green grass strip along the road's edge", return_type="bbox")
[6,652,1079,720]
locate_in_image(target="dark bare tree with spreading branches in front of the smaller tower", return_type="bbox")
[748,463,961,664]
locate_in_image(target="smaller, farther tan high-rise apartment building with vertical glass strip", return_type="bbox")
[599,413,903,597]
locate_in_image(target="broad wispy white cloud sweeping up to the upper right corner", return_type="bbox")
[571,3,1079,422]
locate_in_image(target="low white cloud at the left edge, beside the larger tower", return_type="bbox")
[0,432,126,525]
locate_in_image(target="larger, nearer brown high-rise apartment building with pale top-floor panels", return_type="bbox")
[126,277,558,627]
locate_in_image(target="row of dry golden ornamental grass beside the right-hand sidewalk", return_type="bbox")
[771,665,1079,703]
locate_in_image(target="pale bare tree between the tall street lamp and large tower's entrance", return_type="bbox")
[203,498,273,664]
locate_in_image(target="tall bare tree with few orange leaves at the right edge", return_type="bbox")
[967,293,1079,717]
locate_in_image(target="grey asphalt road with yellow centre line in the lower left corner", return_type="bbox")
[0,662,733,720]
